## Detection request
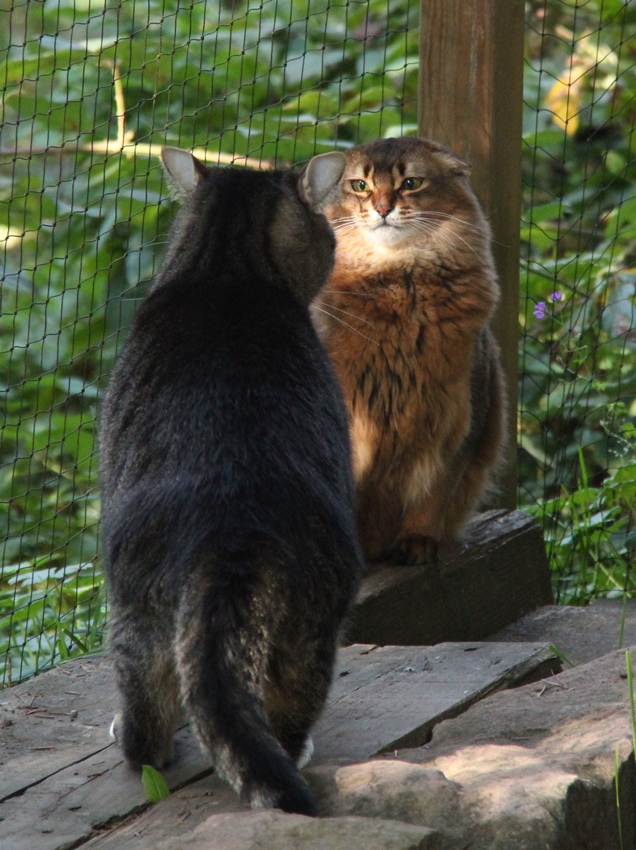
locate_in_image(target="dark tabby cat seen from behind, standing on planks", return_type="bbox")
[101,148,362,815]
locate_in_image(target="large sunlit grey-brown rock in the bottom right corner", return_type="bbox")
[310,651,636,850]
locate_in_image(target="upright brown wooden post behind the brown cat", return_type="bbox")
[419,0,524,507]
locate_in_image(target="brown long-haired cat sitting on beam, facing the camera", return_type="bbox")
[314,138,505,564]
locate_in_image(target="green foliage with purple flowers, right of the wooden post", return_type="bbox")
[519,0,636,603]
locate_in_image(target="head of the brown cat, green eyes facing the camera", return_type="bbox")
[324,137,487,254]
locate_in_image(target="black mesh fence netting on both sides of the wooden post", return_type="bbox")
[0,0,636,684]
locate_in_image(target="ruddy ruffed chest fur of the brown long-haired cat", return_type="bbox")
[320,255,496,480]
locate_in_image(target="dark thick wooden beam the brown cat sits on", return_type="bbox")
[347,511,553,646]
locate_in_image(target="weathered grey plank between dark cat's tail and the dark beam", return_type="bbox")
[314,643,558,761]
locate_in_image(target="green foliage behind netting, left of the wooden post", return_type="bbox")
[0,0,418,683]
